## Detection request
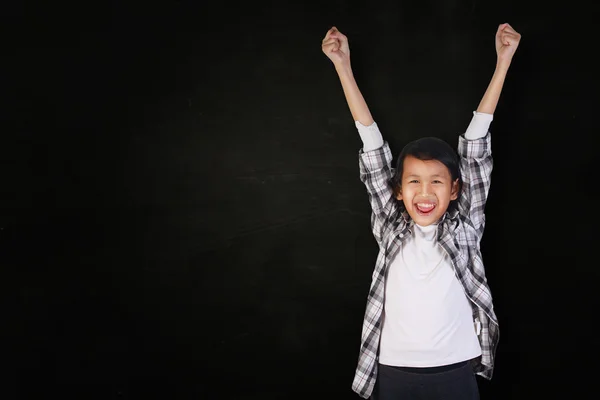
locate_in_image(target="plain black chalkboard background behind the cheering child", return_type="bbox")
[7,0,599,400]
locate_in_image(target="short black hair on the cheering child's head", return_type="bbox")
[392,137,463,210]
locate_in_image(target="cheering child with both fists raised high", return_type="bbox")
[322,24,521,400]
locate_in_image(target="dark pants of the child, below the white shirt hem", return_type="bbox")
[372,361,479,400]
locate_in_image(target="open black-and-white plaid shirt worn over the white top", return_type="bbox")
[352,131,499,399]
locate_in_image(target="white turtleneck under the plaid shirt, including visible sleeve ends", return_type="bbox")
[356,112,493,367]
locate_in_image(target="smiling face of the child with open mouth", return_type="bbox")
[398,156,458,226]
